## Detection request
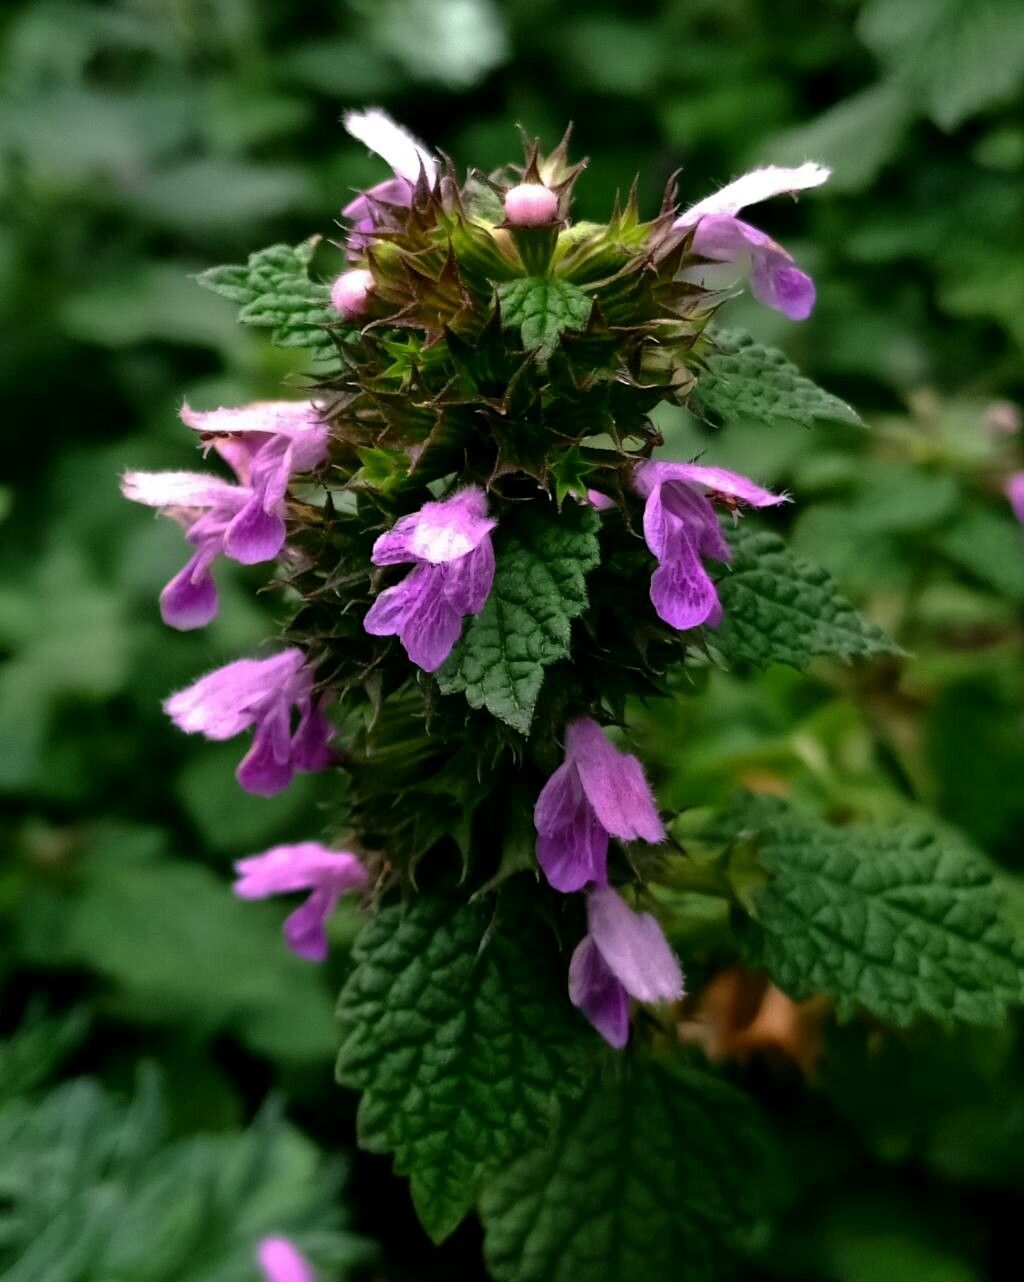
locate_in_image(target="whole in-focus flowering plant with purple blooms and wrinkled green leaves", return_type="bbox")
[124,110,1021,1282]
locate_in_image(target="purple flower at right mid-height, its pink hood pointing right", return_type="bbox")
[634,462,788,631]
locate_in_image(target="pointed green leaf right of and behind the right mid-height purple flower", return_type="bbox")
[710,523,902,670]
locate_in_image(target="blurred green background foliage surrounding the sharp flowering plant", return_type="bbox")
[0,0,1024,1282]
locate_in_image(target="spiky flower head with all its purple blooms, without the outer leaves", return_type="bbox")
[124,112,828,1046]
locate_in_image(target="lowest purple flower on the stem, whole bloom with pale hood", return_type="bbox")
[569,886,683,1050]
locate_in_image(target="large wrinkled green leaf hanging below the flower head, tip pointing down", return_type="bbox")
[338,895,595,1241]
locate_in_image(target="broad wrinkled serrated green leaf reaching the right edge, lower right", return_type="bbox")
[733,810,1024,1027]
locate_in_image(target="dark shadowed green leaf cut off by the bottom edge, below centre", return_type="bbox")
[481,1059,763,1282]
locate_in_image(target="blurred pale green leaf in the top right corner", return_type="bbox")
[857,0,1024,129]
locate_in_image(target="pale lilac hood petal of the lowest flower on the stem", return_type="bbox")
[587,886,683,1001]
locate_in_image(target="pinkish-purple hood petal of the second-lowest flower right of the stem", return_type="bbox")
[565,717,665,842]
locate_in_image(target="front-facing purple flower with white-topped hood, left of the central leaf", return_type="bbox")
[363,486,497,672]
